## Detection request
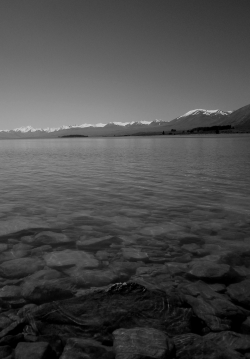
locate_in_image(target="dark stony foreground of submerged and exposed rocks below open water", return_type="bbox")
[0,229,250,359]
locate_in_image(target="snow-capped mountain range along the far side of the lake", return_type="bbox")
[0,105,250,138]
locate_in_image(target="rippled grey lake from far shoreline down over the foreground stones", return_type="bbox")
[0,135,250,359]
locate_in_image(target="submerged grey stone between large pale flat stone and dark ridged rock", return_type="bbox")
[65,267,119,287]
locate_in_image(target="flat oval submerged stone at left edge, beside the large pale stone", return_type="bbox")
[0,258,44,278]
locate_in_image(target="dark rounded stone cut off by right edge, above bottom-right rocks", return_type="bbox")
[227,279,250,309]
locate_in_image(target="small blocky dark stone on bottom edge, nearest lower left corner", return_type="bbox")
[15,342,52,359]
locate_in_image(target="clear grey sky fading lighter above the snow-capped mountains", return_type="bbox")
[0,0,250,129]
